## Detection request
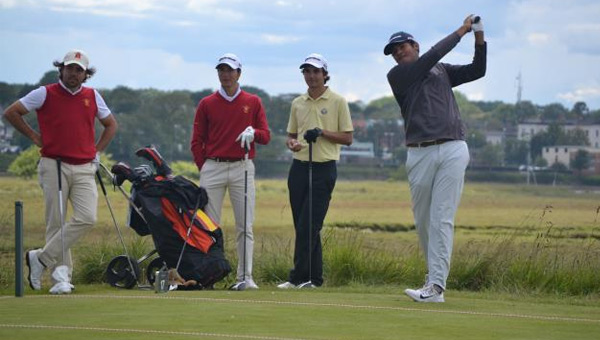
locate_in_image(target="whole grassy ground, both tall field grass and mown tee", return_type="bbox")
[0,177,600,339]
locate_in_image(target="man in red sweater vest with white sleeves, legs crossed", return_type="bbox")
[4,50,117,294]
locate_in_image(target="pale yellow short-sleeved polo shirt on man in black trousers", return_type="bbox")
[287,87,354,162]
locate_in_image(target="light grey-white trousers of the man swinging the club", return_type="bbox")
[406,140,469,289]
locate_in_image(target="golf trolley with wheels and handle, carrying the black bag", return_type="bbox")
[97,146,231,290]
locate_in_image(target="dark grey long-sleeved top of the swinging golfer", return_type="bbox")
[387,32,487,144]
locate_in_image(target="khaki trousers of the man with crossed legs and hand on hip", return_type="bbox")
[38,157,98,273]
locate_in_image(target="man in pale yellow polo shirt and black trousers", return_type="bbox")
[277,53,354,289]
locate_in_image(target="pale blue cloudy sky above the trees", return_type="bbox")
[0,0,600,110]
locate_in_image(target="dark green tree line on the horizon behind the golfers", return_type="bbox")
[0,71,600,166]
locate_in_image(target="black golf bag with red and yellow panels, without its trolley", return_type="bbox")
[118,148,231,289]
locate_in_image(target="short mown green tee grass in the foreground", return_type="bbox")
[0,286,600,340]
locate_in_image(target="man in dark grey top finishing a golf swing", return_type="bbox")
[383,15,487,302]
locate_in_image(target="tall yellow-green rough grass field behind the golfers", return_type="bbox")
[0,178,600,298]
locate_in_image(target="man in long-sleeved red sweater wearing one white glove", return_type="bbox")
[191,53,271,290]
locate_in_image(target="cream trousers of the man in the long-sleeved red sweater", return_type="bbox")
[200,159,255,281]
